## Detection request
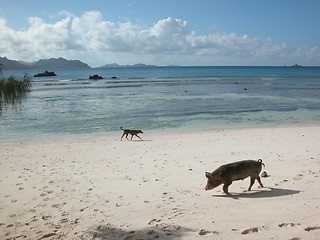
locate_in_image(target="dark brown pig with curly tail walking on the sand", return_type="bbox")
[205,159,265,194]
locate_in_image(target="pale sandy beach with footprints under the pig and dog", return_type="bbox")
[0,126,320,240]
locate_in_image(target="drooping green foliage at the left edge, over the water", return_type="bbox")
[0,64,31,115]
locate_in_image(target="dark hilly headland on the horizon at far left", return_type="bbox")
[0,57,90,70]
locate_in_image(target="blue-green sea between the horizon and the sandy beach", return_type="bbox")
[0,66,320,144]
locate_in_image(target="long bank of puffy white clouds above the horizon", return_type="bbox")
[0,11,320,65]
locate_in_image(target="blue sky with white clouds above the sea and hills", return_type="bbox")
[0,0,320,67]
